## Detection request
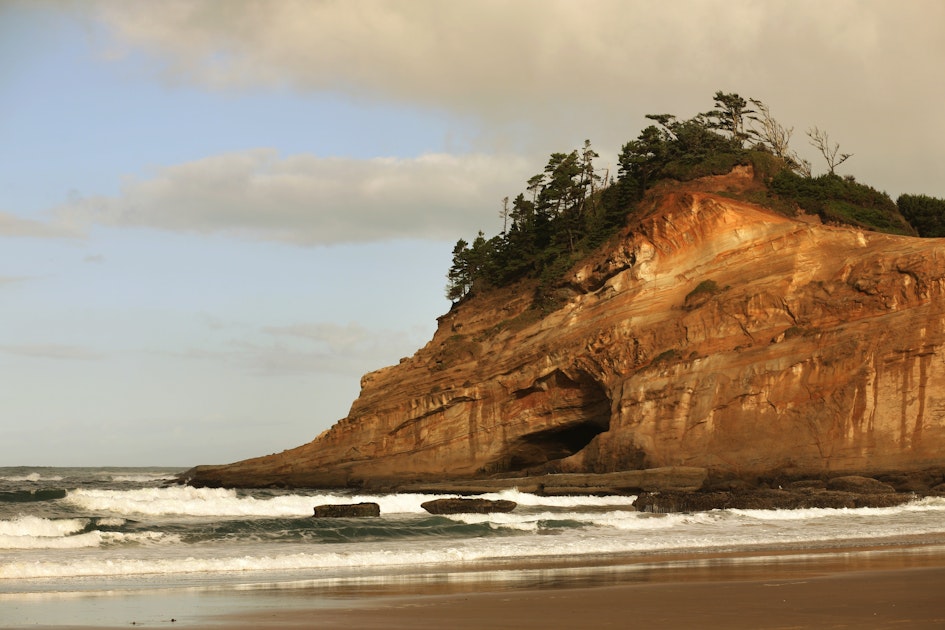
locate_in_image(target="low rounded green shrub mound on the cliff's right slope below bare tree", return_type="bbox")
[770,170,914,234]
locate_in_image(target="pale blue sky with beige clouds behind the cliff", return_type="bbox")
[0,0,945,467]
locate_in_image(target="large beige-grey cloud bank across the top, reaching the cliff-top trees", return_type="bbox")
[57,0,945,198]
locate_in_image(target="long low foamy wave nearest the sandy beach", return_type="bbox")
[0,527,940,580]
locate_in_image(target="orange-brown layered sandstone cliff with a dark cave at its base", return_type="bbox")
[186,170,945,487]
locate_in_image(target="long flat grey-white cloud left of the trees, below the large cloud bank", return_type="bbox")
[56,149,529,245]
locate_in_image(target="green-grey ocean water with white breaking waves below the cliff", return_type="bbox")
[0,467,945,627]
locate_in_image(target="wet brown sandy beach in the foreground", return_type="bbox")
[12,543,945,630]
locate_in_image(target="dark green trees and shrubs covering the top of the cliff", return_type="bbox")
[446,91,928,313]
